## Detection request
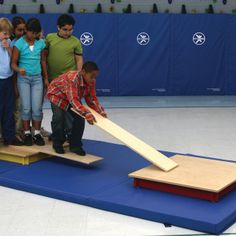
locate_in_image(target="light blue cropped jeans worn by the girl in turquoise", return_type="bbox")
[17,74,43,121]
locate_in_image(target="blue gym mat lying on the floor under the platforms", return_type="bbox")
[0,140,236,234]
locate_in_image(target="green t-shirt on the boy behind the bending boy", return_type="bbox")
[46,33,83,81]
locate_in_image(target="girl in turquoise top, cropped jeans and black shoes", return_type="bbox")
[12,18,48,146]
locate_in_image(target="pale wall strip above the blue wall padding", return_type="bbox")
[0,0,236,13]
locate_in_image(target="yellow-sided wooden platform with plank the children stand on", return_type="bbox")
[0,143,103,165]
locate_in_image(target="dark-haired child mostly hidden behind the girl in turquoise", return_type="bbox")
[11,16,25,139]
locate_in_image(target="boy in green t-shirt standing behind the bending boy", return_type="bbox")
[46,14,83,81]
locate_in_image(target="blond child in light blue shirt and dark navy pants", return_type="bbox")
[0,18,22,145]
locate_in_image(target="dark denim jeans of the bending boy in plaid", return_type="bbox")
[51,103,85,148]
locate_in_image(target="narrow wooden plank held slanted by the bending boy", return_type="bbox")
[72,106,178,171]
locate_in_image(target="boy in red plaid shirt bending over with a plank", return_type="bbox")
[47,62,107,156]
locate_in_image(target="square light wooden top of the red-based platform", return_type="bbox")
[129,155,236,192]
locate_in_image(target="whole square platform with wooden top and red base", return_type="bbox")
[129,155,236,201]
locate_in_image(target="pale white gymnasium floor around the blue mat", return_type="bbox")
[0,96,236,236]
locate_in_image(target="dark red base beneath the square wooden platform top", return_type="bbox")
[134,178,236,202]
